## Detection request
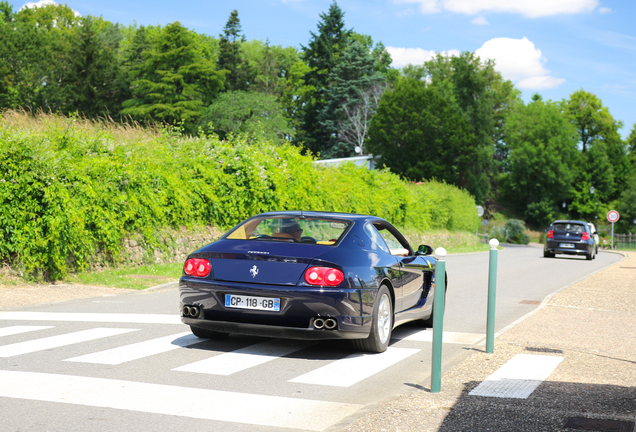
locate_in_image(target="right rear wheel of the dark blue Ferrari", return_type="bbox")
[352,285,393,353]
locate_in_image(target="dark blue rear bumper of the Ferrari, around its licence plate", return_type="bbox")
[179,277,377,339]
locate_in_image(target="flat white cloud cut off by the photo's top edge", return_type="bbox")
[394,0,599,18]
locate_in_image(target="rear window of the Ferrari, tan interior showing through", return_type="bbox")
[225,216,351,246]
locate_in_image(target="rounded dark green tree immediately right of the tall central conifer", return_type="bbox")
[367,78,475,185]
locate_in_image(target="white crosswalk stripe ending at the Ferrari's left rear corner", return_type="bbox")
[65,332,203,365]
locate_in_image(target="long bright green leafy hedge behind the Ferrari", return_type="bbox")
[0,111,475,280]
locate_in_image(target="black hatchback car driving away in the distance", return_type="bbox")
[543,220,596,260]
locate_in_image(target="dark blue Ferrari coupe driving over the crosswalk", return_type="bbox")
[179,211,444,352]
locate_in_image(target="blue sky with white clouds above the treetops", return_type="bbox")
[10,0,636,137]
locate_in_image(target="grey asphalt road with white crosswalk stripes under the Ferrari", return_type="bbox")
[0,246,621,432]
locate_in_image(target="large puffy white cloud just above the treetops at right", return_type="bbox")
[475,37,565,90]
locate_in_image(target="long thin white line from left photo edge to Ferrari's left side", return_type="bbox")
[0,311,182,324]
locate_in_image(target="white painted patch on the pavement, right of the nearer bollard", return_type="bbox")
[468,354,563,399]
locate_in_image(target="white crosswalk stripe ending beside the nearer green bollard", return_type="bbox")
[289,348,420,387]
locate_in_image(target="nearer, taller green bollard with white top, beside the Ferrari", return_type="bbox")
[431,247,446,393]
